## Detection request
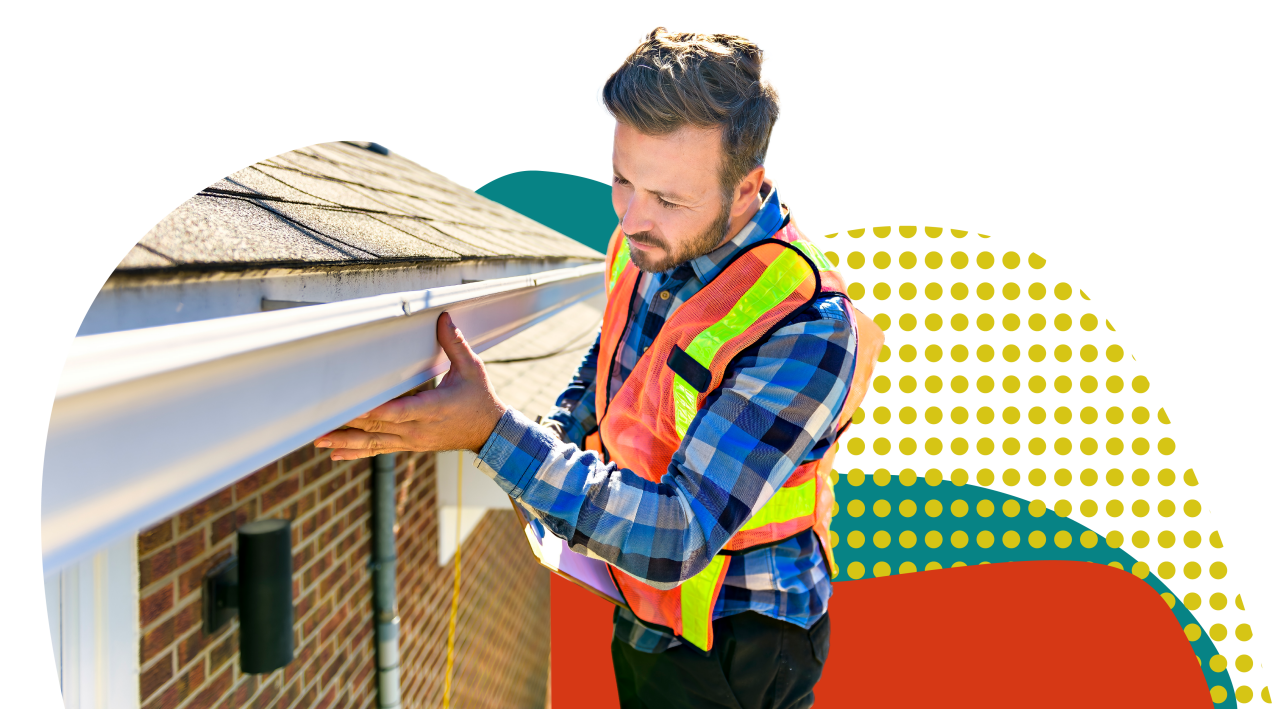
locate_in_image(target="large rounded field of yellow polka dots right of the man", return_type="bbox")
[827,227,1270,704]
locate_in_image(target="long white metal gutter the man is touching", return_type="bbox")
[41,264,604,573]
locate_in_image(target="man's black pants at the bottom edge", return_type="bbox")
[612,613,831,709]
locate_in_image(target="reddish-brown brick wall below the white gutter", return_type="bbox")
[138,445,549,709]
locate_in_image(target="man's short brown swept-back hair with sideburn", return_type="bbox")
[604,27,778,201]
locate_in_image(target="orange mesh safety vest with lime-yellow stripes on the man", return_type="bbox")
[586,218,883,650]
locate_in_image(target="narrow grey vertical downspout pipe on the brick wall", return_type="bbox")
[369,453,401,709]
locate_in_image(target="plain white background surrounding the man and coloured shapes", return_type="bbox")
[0,1,1280,706]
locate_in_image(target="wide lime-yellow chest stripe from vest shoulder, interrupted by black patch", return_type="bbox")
[673,248,813,438]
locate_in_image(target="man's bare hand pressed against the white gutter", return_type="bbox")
[315,312,507,461]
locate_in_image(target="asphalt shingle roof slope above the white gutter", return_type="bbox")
[116,142,603,273]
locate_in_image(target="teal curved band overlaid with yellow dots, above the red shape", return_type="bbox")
[831,471,1236,708]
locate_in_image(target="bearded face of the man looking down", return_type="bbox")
[613,122,730,273]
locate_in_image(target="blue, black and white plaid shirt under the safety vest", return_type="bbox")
[479,188,855,653]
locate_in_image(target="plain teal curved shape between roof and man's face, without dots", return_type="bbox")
[476,170,618,253]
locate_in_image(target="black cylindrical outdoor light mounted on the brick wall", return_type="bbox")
[204,520,293,674]
